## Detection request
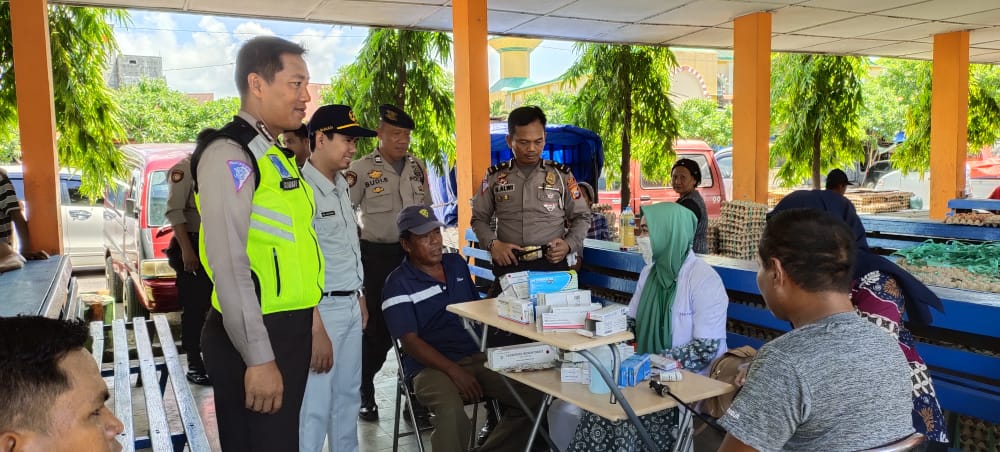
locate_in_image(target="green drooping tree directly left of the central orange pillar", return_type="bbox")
[321,28,455,167]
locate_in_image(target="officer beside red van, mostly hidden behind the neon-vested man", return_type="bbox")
[166,156,212,385]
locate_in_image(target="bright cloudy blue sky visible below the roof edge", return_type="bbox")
[115,11,575,98]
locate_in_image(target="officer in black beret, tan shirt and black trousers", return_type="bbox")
[345,105,431,421]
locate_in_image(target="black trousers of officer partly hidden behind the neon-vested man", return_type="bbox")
[166,234,212,369]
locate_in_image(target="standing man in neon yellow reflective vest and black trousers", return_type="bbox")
[191,37,323,452]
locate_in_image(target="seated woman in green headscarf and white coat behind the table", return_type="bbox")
[549,202,729,451]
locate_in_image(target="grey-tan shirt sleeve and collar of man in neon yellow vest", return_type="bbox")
[198,111,282,366]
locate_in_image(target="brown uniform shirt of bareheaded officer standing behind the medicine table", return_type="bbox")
[472,160,590,252]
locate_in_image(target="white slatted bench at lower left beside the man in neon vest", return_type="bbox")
[90,315,211,452]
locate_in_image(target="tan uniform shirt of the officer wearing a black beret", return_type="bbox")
[344,151,431,243]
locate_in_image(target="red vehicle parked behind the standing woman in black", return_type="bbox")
[597,140,726,218]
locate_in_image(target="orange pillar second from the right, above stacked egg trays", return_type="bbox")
[733,12,771,203]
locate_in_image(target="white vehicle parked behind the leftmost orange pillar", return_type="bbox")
[3,166,104,270]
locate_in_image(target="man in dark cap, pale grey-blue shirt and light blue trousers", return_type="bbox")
[299,105,375,452]
